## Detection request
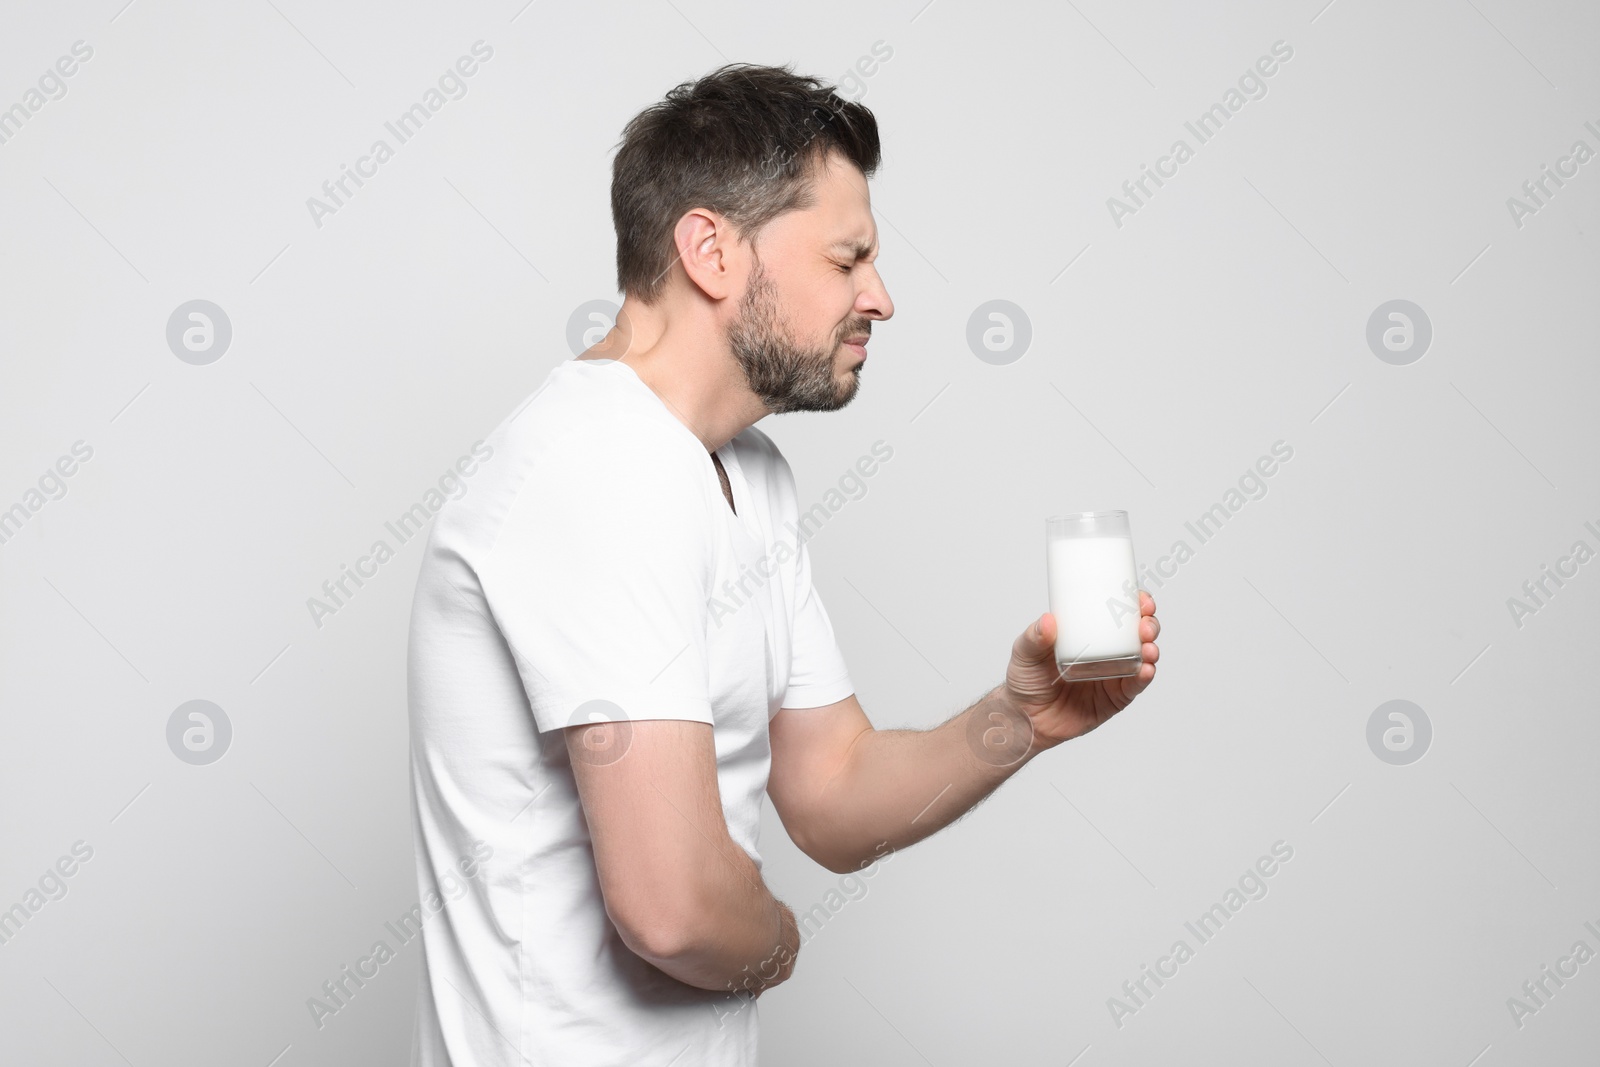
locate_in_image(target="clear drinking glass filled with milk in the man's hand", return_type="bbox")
[1045,512,1142,681]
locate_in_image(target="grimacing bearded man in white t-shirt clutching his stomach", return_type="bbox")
[410,64,1158,1067]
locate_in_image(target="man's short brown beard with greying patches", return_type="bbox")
[728,261,870,414]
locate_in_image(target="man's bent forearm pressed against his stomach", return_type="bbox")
[640,841,800,993]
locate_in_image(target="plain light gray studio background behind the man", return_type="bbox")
[0,0,1600,1067]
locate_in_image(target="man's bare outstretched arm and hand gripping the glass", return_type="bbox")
[766,592,1160,873]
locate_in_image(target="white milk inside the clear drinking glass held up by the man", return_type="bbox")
[1048,537,1141,662]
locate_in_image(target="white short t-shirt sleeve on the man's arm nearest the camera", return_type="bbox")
[478,440,714,733]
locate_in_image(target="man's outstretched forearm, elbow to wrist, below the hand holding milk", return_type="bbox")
[810,686,1042,870]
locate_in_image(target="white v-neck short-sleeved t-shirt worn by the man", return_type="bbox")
[408,360,854,1067]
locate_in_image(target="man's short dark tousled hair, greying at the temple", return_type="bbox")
[611,62,882,304]
